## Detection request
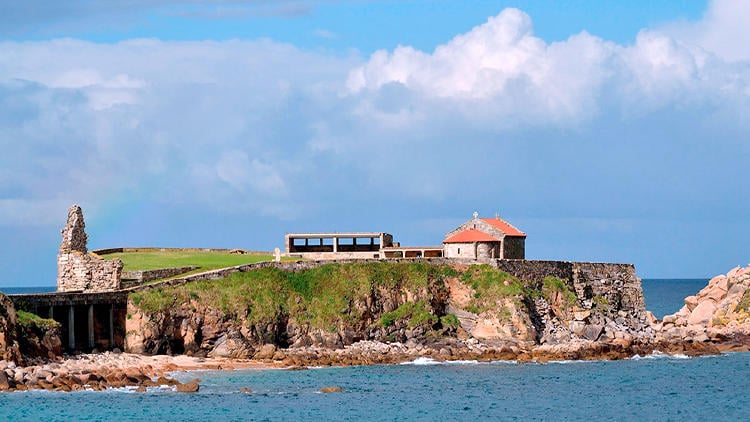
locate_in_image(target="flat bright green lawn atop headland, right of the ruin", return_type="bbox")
[102,251,273,271]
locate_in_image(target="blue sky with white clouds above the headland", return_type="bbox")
[0,0,750,287]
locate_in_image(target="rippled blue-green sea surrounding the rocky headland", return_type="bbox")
[0,279,750,421]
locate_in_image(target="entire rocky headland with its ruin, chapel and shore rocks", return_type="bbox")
[0,206,750,391]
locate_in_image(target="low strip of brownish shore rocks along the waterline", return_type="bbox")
[0,337,750,393]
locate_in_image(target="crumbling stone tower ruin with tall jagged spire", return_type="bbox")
[57,205,122,293]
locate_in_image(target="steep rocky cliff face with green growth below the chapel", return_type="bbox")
[126,261,650,357]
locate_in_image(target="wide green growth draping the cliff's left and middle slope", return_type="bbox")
[130,261,452,330]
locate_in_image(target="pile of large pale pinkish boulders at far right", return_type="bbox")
[654,266,750,350]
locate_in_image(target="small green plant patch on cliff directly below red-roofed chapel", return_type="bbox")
[461,265,527,314]
